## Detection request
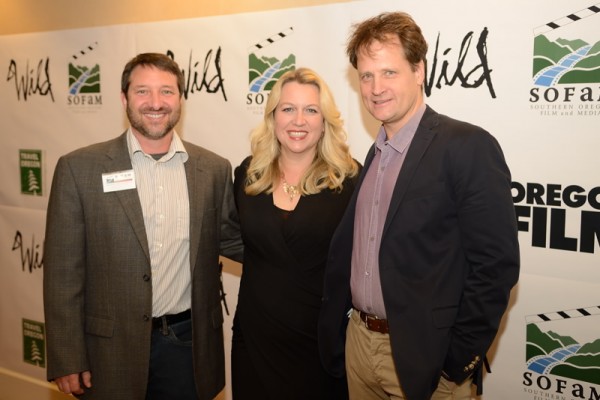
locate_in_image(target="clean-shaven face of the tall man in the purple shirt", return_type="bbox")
[356,38,425,139]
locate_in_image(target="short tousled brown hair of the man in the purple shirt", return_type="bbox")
[346,12,427,68]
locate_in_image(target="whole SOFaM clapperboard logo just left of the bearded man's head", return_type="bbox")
[67,42,102,108]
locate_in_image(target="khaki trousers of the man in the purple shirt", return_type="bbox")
[346,311,471,400]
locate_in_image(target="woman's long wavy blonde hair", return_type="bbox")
[245,68,358,195]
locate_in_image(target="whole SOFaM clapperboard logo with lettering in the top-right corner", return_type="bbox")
[529,3,600,116]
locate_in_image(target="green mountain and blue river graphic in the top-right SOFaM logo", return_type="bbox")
[533,35,600,87]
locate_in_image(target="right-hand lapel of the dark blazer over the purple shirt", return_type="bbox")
[382,106,438,236]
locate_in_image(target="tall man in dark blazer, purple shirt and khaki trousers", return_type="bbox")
[319,13,519,400]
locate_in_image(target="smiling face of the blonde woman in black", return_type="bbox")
[274,81,324,159]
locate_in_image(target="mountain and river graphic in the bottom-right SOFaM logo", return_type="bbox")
[526,323,600,385]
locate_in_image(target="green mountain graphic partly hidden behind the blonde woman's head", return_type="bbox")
[248,53,296,93]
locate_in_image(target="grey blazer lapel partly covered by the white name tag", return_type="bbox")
[105,133,150,263]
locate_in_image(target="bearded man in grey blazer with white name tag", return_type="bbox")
[44,53,243,400]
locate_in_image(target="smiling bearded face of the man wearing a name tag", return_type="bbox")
[121,65,181,140]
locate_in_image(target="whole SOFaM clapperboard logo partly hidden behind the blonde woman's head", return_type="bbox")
[246,27,296,114]
